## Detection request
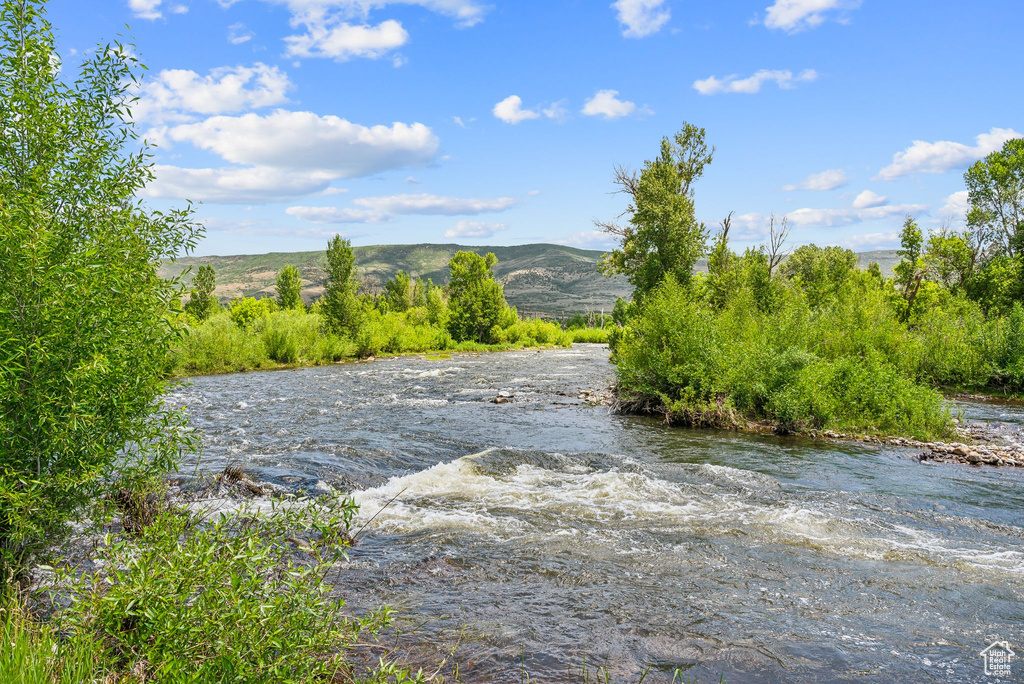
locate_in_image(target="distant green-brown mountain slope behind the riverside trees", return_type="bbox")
[155,244,899,315]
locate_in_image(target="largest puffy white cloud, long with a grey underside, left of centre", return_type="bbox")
[167,110,439,178]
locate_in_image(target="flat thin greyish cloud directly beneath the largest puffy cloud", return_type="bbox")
[143,164,333,204]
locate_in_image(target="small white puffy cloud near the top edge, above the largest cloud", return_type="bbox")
[285,19,409,61]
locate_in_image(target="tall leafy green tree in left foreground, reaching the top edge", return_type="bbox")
[0,0,202,582]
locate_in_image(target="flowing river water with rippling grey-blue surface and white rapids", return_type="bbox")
[177,345,1024,682]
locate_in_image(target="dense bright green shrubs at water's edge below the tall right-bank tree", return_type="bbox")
[615,274,950,437]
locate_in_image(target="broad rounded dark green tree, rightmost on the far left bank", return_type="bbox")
[447,252,507,342]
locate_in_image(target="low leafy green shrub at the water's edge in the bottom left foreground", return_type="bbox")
[61,500,389,684]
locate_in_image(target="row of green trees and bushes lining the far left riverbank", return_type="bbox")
[171,244,577,375]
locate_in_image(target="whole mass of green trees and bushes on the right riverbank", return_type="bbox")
[604,126,1024,444]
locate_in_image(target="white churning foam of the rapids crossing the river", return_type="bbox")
[354,450,1024,576]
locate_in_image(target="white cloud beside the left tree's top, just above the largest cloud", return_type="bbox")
[132,62,293,123]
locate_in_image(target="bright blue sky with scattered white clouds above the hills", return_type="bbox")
[49,0,1024,254]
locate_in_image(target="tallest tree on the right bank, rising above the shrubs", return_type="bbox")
[597,124,715,300]
